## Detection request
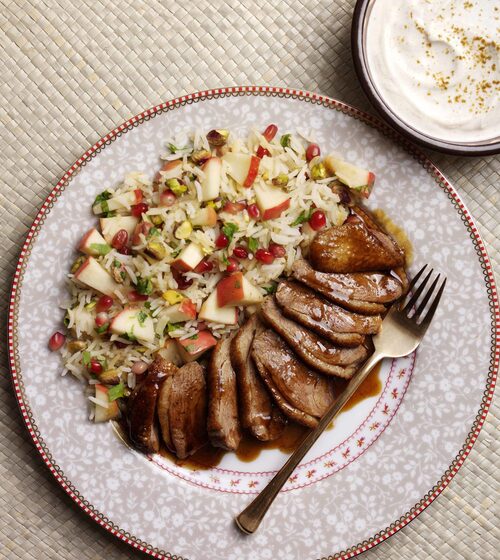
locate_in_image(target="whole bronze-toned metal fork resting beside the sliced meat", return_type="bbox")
[235,265,446,535]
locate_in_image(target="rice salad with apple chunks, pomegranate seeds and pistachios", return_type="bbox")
[49,125,374,422]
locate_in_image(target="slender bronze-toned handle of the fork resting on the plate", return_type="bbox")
[235,352,384,535]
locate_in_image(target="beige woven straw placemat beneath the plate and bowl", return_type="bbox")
[0,0,500,560]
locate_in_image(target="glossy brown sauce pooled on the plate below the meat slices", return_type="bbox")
[160,363,382,471]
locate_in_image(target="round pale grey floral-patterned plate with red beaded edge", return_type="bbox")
[9,87,499,560]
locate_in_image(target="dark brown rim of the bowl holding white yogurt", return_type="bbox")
[351,0,500,156]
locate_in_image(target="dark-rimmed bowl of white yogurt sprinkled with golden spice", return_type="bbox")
[352,0,500,155]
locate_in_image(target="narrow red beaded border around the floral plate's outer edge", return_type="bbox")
[7,86,500,560]
